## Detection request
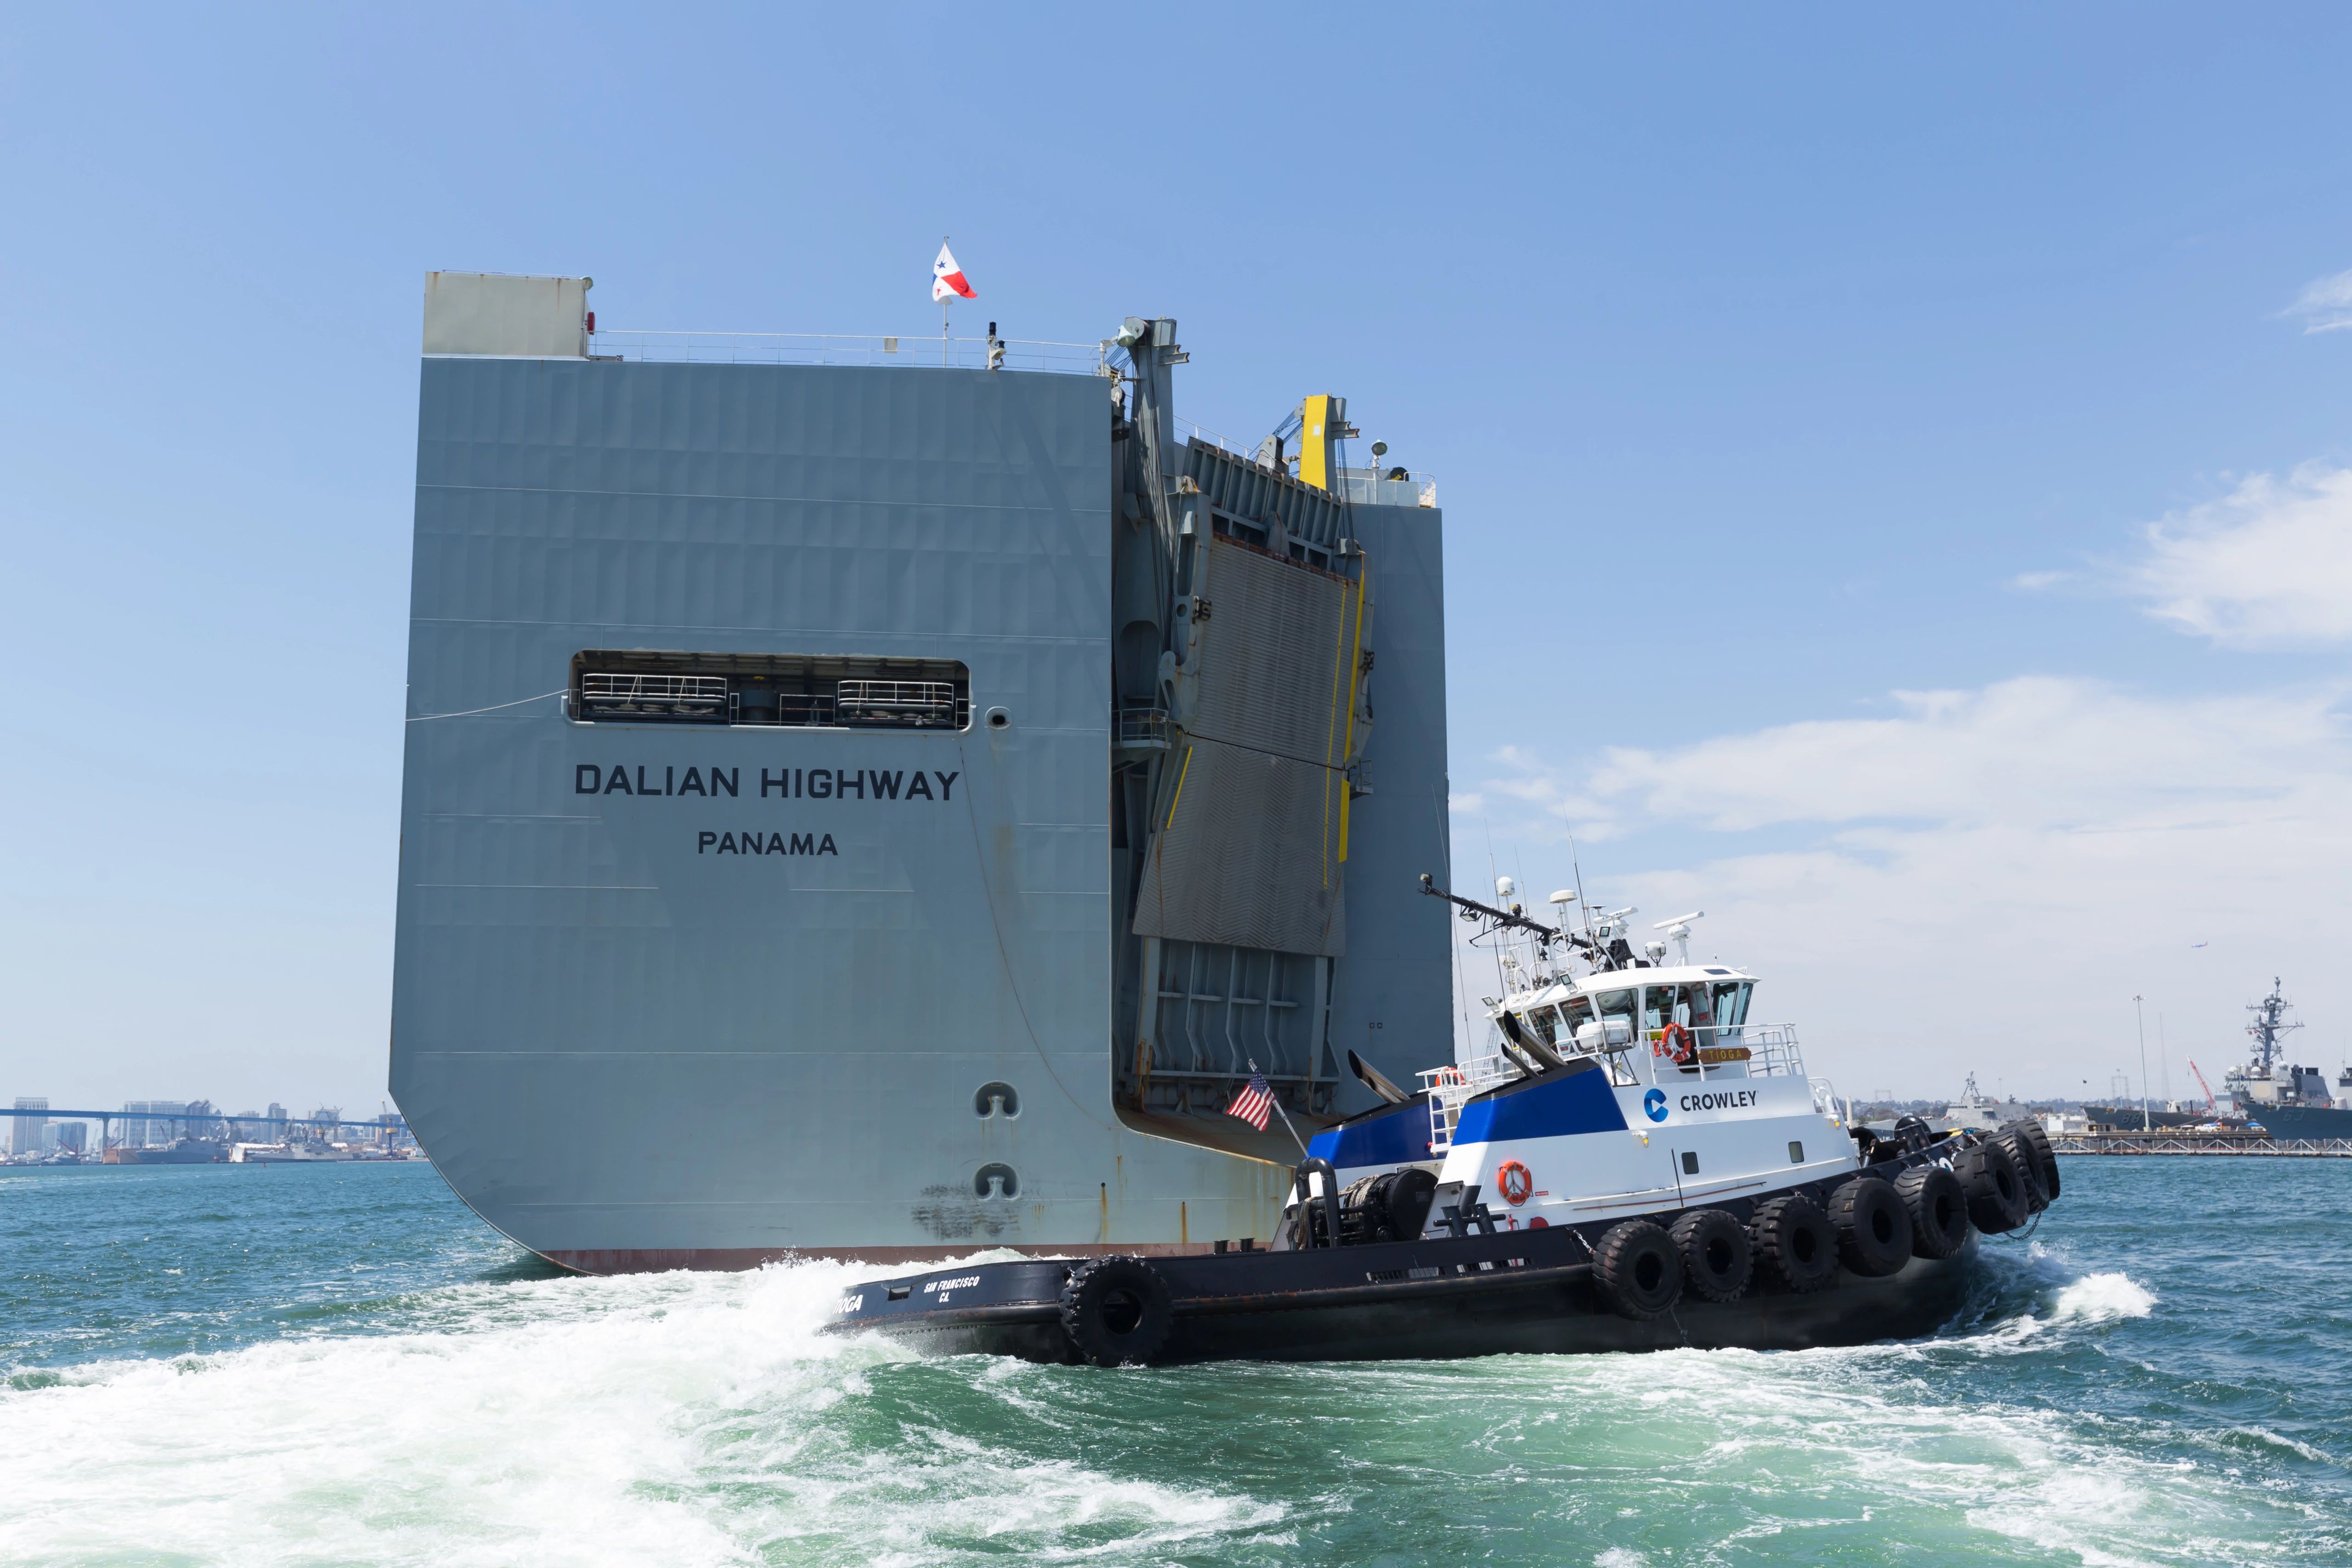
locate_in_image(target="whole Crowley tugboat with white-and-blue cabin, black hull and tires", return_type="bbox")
[825,877,2058,1366]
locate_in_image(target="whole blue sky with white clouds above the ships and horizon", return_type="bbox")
[0,5,2352,1109]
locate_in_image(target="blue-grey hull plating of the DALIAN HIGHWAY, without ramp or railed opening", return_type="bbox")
[390,334,1451,1272]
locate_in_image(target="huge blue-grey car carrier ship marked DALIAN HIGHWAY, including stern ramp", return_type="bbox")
[390,273,1451,1272]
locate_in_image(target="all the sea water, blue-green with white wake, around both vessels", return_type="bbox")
[0,1157,2352,1568]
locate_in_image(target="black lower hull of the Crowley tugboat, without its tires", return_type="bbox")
[828,1232,1976,1366]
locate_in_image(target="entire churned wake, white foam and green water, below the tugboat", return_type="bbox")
[0,1253,2307,1568]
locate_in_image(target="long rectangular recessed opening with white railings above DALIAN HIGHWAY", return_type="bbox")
[567,649,972,729]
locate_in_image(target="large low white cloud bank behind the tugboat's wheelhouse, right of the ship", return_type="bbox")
[1465,677,2352,1093]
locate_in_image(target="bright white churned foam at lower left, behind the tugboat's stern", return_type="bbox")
[0,1265,1279,1568]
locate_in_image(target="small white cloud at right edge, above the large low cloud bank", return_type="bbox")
[2119,463,2352,649]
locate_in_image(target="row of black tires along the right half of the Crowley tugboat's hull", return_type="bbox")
[1592,1121,2058,1319]
